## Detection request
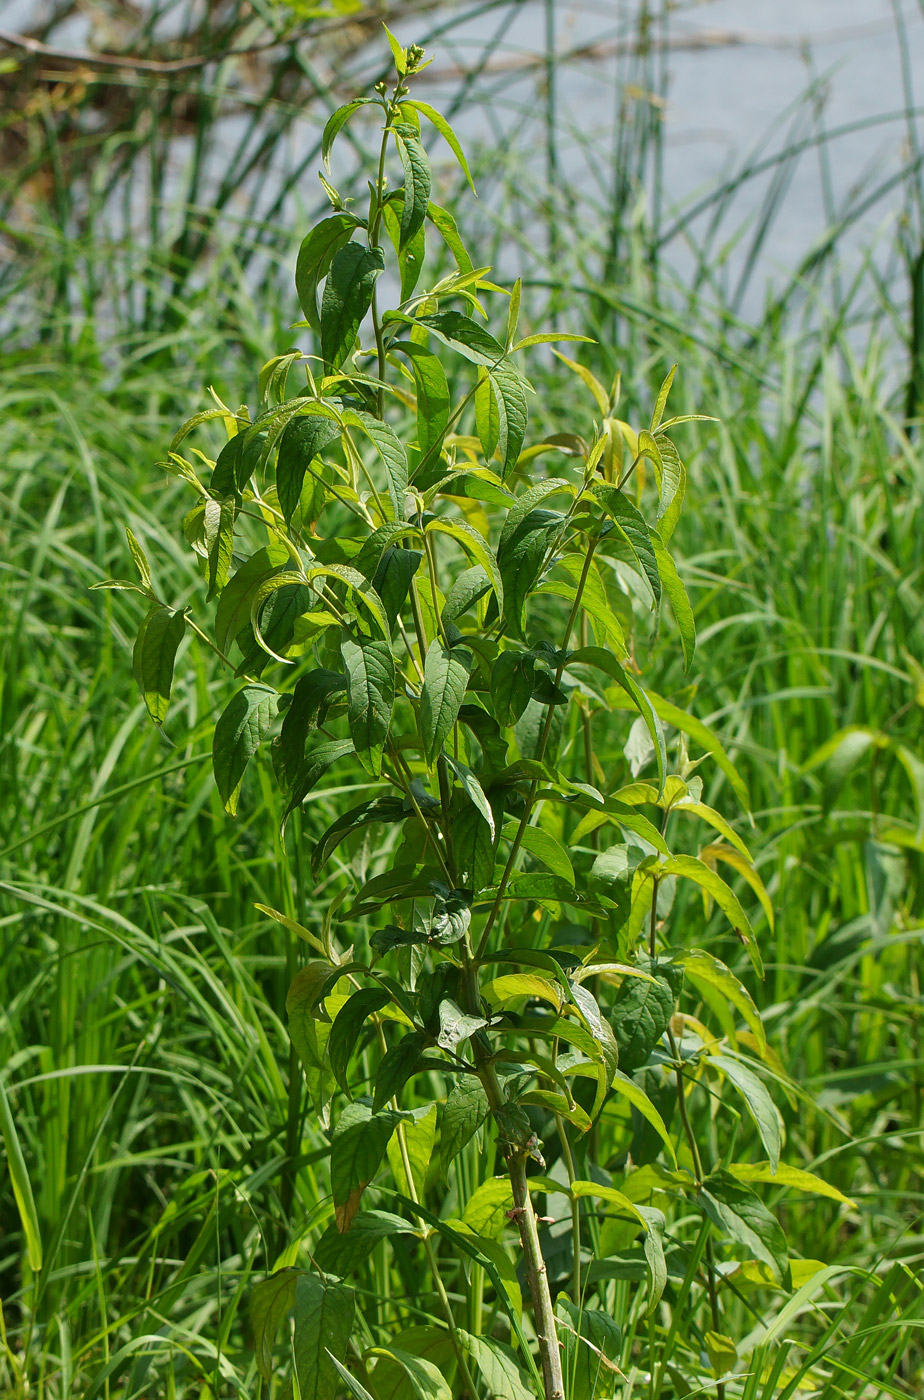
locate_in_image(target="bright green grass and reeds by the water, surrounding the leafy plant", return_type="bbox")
[0,3,924,1400]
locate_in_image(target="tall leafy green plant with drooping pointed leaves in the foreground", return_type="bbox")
[91,30,844,1400]
